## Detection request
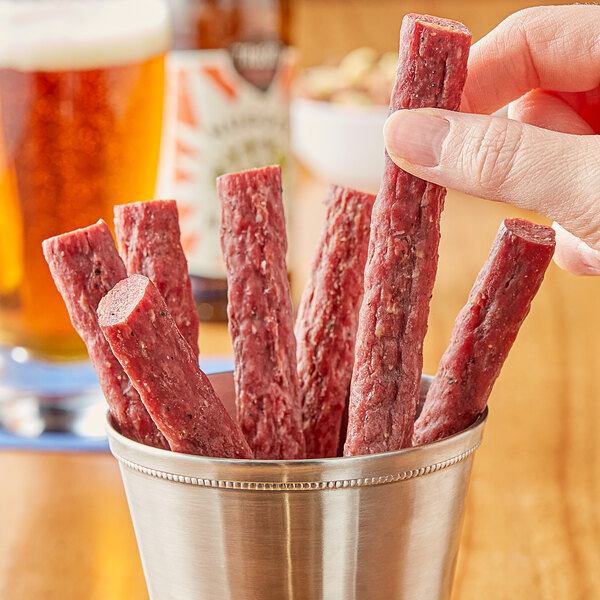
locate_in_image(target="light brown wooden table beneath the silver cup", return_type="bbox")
[0,173,600,600]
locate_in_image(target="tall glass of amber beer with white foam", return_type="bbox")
[0,0,171,434]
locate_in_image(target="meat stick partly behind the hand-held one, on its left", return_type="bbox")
[295,185,375,458]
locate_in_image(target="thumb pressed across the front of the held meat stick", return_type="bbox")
[384,108,600,249]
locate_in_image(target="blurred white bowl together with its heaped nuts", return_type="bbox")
[291,47,398,192]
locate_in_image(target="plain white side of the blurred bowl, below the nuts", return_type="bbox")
[291,98,388,192]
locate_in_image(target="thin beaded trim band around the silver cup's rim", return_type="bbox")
[115,442,480,492]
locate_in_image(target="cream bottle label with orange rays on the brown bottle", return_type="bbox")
[157,41,293,278]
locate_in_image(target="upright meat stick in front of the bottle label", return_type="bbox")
[217,167,304,459]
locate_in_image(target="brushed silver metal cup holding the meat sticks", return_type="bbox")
[108,373,487,600]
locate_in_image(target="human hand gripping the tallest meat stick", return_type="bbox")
[384,5,600,275]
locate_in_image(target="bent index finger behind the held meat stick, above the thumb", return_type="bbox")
[461,5,600,114]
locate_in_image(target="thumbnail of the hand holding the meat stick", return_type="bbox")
[383,110,450,167]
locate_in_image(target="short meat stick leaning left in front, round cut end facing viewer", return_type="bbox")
[98,275,252,459]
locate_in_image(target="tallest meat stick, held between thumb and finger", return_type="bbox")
[344,14,471,456]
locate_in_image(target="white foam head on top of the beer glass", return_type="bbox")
[0,0,171,71]
